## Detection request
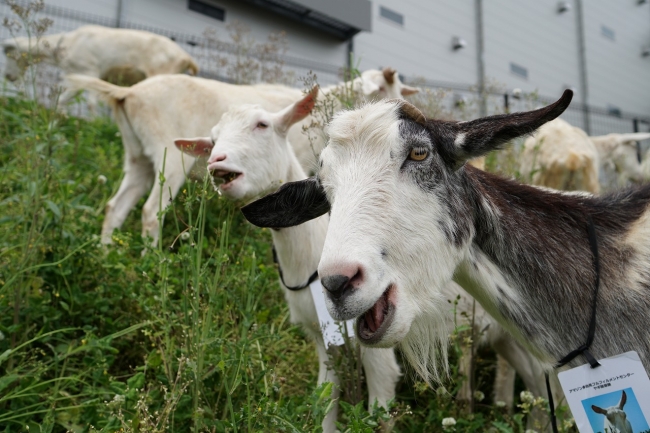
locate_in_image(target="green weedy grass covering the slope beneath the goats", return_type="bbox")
[0,93,572,432]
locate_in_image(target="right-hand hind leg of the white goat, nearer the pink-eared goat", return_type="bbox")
[142,159,185,246]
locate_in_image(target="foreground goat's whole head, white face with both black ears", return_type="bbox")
[242,91,572,346]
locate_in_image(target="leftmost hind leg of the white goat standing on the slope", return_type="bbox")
[102,154,154,244]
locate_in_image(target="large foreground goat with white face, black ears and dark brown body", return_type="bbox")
[242,90,650,384]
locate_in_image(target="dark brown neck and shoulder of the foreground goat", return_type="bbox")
[455,169,650,367]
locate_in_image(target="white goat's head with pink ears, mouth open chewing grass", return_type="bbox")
[175,89,317,201]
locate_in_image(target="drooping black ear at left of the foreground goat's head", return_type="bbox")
[241,177,330,228]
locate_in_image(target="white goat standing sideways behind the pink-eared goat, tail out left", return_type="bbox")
[66,69,418,245]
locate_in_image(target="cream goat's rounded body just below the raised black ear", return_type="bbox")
[520,119,600,193]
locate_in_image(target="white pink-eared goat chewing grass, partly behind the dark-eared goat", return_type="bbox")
[175,88,400,432]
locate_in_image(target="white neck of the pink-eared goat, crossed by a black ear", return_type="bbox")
[271,158,328,286]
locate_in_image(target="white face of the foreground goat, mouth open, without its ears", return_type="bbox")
[318,103,462,346]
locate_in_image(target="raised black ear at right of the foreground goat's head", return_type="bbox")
[443,90,573,168]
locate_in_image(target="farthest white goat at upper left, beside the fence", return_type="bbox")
[2,25,198,106]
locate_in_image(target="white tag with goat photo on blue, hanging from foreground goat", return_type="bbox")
[558,352,650,433]
